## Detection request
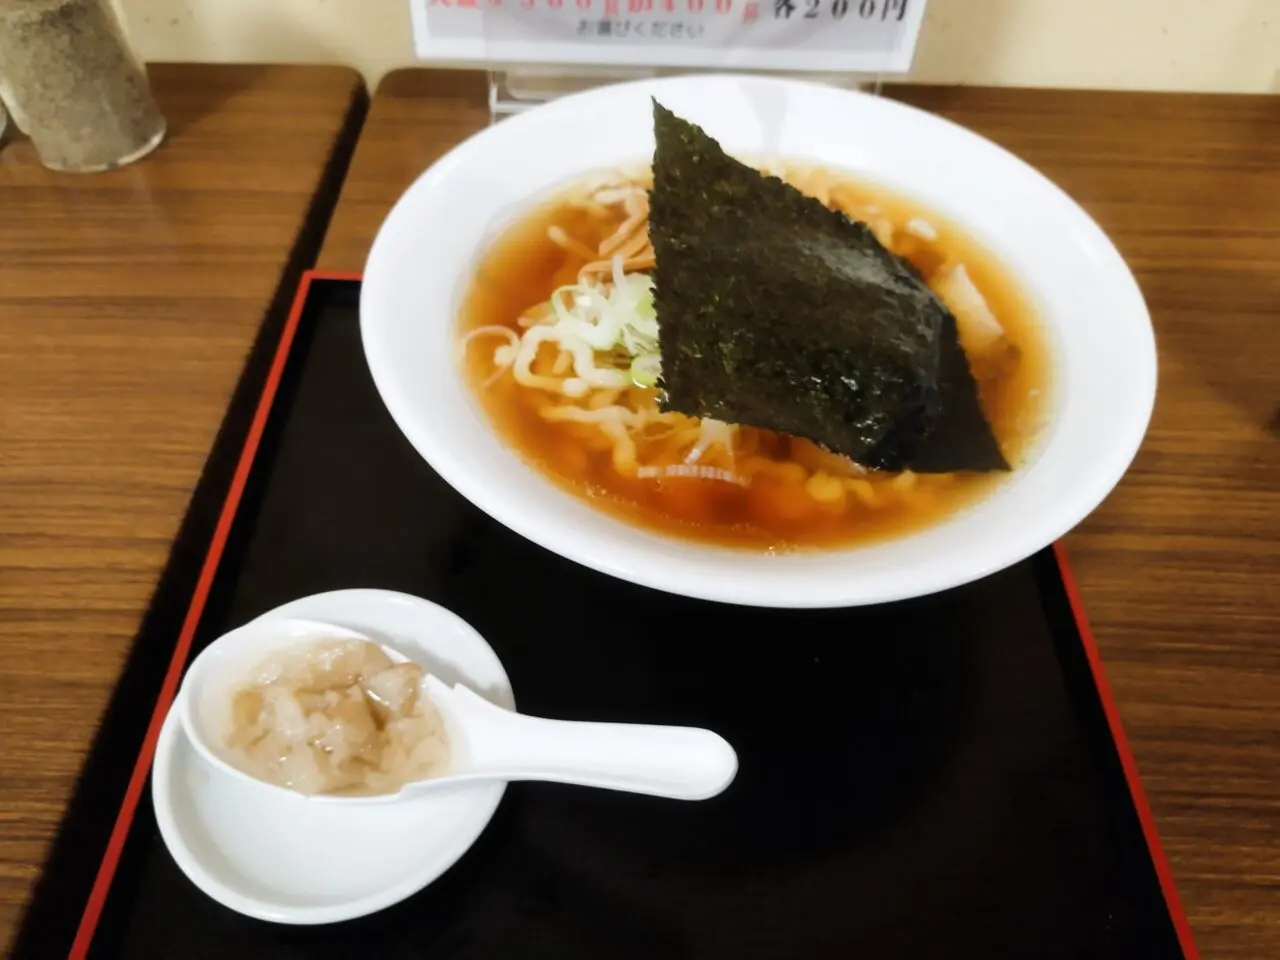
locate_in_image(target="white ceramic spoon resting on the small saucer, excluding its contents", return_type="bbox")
[178,620,737,804]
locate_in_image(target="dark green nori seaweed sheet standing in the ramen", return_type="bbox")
[649,101,1009,472]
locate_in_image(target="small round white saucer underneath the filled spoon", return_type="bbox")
[151,590,515,924]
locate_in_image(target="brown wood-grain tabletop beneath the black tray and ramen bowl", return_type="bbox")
[319,70,1280,960]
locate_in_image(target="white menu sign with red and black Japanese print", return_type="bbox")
[410,0,925,73]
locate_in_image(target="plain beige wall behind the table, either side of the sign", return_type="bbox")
[116,0,1280,92]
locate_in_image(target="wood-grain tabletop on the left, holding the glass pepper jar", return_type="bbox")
[0,65,364,957]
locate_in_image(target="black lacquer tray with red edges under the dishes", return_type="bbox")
[15,275,1196,960]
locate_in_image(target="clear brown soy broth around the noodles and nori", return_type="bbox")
[460,166,1050,549]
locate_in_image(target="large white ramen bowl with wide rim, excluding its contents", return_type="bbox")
[360,76,1156,607]
